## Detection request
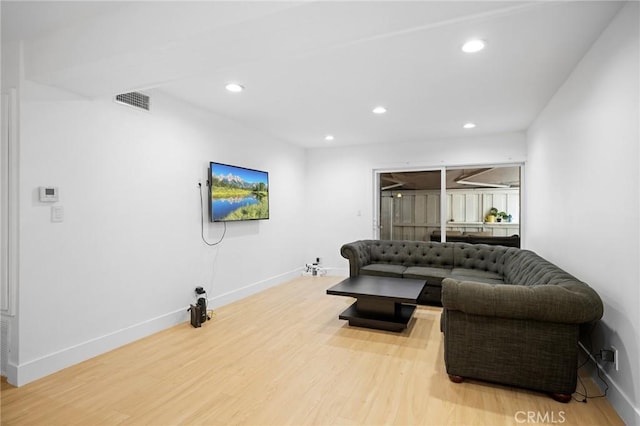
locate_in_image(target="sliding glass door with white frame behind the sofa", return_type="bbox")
[378,165,521,241]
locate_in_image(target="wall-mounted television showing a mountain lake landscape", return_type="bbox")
[209,162,269,222]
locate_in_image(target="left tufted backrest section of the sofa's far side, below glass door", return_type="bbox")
[369,240,453,269]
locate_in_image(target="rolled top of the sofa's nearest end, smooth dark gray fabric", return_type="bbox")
[442,278,603,324]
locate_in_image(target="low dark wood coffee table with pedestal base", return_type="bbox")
[327,275,425,331]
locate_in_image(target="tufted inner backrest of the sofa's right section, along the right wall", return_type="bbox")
[504,250,579,285]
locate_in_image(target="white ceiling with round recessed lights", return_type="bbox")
[0,0,622,147]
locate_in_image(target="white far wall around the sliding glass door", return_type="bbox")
[306,133,526,275]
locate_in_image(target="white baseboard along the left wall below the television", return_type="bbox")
[6,268,302,386]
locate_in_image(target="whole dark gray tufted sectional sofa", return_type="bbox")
[340,240,603,402]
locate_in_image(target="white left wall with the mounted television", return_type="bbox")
[10,81,305,385]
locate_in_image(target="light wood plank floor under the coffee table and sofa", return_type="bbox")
[1,277,623,425]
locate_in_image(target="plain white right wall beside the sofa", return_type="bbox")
[523,2,640,424]
